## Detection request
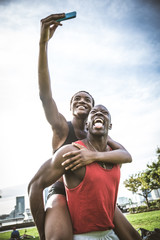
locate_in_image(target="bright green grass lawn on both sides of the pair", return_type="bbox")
[0,210,160,240]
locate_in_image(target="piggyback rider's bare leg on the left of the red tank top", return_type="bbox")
[45,194,73,240]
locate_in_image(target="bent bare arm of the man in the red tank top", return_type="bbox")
[28,147,65,240]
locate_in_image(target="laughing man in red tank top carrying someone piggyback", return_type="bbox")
[29,105,120,240]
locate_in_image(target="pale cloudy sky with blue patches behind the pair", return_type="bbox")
[0,0,160,214]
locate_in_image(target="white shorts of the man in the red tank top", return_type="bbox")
[73,230,119,240]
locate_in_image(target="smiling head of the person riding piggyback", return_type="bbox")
[71,92,93,117]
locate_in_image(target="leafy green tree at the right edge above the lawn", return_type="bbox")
[124,148,160,208]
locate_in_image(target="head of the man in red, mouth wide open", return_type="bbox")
[87,105,112,136]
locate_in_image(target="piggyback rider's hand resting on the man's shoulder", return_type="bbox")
[62,143,96,171]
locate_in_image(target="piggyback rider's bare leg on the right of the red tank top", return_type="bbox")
[113,207,142,240]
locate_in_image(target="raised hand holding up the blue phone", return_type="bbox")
[40,13,65,43]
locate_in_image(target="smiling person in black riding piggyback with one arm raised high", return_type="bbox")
[35,14,141,240]
